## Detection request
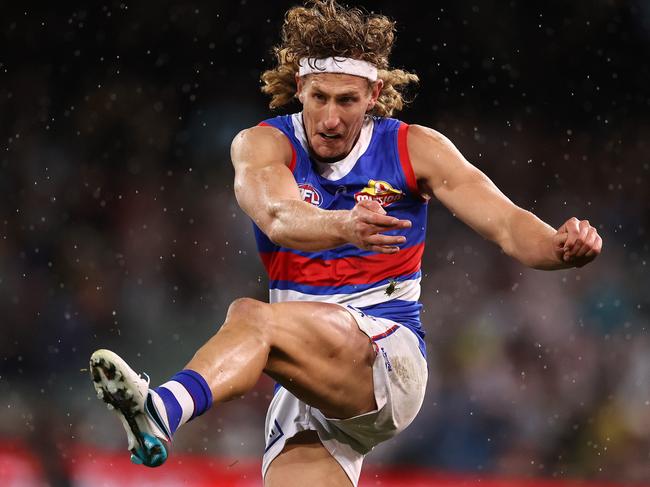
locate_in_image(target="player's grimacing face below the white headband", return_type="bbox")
[298,73,381,162]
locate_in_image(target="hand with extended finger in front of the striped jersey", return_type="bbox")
[346,200,411,254]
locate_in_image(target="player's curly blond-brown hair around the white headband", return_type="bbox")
[262,0,419,117]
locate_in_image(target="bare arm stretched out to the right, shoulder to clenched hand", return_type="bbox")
[408,125,602,269]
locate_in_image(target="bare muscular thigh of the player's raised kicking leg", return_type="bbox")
[264,302,376,418]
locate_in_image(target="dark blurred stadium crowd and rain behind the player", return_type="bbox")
[0,0,650,487]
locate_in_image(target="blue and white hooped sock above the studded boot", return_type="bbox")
[147,369,212,440]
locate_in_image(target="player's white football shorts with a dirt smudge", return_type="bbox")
[262,306,428,486]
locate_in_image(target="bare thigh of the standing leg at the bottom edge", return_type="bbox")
[264,431,352,487]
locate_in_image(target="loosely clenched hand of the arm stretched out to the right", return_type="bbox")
[553,217,603,267]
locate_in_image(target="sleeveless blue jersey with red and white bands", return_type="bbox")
[253,113,427,355]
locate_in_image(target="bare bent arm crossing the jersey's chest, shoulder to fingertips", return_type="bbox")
[231,126,410,253]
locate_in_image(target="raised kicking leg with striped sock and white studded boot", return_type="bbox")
[91,299,376,466]
